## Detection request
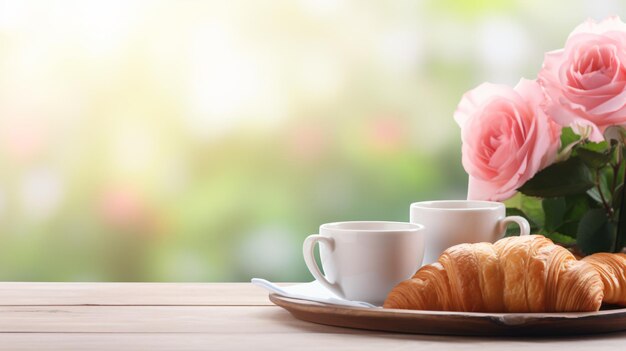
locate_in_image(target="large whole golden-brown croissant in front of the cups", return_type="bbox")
[383,235,603,312]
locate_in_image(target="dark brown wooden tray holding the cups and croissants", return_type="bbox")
[269,294,626,336]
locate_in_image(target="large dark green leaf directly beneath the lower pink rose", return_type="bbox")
[518,157,594,197]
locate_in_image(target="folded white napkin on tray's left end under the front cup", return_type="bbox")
[251,278,378,308]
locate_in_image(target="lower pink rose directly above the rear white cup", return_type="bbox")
[454,79,561,201]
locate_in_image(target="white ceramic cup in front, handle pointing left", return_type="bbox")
[302,221,424,305]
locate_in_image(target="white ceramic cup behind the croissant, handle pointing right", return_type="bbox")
[411,200,530,265]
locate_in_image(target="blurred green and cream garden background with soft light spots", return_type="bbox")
[0,0,624,281]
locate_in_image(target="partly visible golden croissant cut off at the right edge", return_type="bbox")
[583,252,626,306]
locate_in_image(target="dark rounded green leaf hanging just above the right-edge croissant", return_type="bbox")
[576,208,615,255]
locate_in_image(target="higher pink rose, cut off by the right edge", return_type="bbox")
[538,17,626,141]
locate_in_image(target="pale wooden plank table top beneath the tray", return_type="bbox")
[0,283,626,351]
